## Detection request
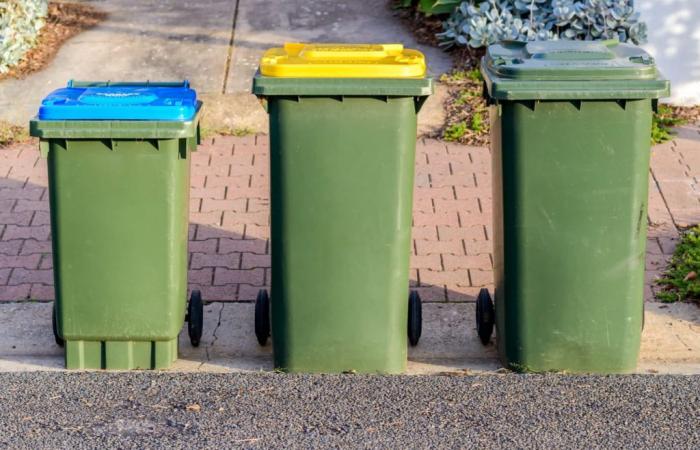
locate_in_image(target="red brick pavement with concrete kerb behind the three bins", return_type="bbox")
[0,126,700,373]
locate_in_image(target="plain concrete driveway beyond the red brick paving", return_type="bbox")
[0,0,452,132]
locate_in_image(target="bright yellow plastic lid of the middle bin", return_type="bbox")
[260,43,425,78]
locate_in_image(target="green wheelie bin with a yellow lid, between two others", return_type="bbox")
[253,43,433,373]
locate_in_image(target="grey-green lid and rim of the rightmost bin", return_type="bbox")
[481,40,669,100]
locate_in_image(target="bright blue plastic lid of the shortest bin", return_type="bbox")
[38,81,197,121]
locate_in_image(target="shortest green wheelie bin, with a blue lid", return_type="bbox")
[30,81,203,370]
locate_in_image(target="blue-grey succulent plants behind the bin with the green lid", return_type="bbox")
[438,0,646,48]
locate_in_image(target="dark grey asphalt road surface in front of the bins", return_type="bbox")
[0,372,700,449]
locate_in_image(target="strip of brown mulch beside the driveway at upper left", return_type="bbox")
[0,2,107,80]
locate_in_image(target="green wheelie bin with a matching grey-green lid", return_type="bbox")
[477,41,669,373]
